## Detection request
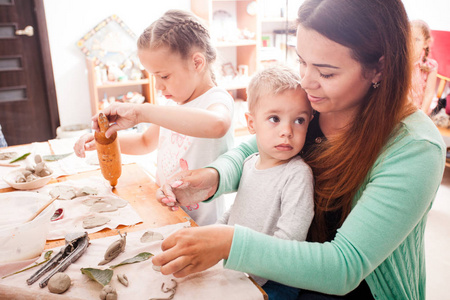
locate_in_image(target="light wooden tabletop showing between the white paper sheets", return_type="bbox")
[0,164,267,299]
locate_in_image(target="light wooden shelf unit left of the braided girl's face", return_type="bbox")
[86,58,155,115]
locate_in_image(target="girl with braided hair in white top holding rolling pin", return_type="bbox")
[74,10,234,225]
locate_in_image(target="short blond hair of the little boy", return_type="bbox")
[247,65,301,113]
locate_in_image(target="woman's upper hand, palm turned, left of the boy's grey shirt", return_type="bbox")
[156,168,219,210]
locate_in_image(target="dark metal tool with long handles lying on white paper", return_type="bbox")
[27,232,89,288]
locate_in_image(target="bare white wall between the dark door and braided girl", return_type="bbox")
[44,0,190,126]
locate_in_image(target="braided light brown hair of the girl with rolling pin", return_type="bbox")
[137,9,217,82]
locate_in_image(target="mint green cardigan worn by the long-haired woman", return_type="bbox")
[210,111,446,300]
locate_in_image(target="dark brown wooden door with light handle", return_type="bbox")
[0,0,59,145]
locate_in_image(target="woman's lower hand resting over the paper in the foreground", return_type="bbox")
[152,225,234,277]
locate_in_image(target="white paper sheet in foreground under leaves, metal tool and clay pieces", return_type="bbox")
[0,222,263,300]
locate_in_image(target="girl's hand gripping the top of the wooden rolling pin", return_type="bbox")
[92,103,140,138]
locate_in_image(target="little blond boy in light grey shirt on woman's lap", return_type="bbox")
[218,66,314,299]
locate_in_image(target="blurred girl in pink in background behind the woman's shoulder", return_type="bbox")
[410,20,438,115]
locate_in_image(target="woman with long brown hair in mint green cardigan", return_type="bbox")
[153,0,445,299]
